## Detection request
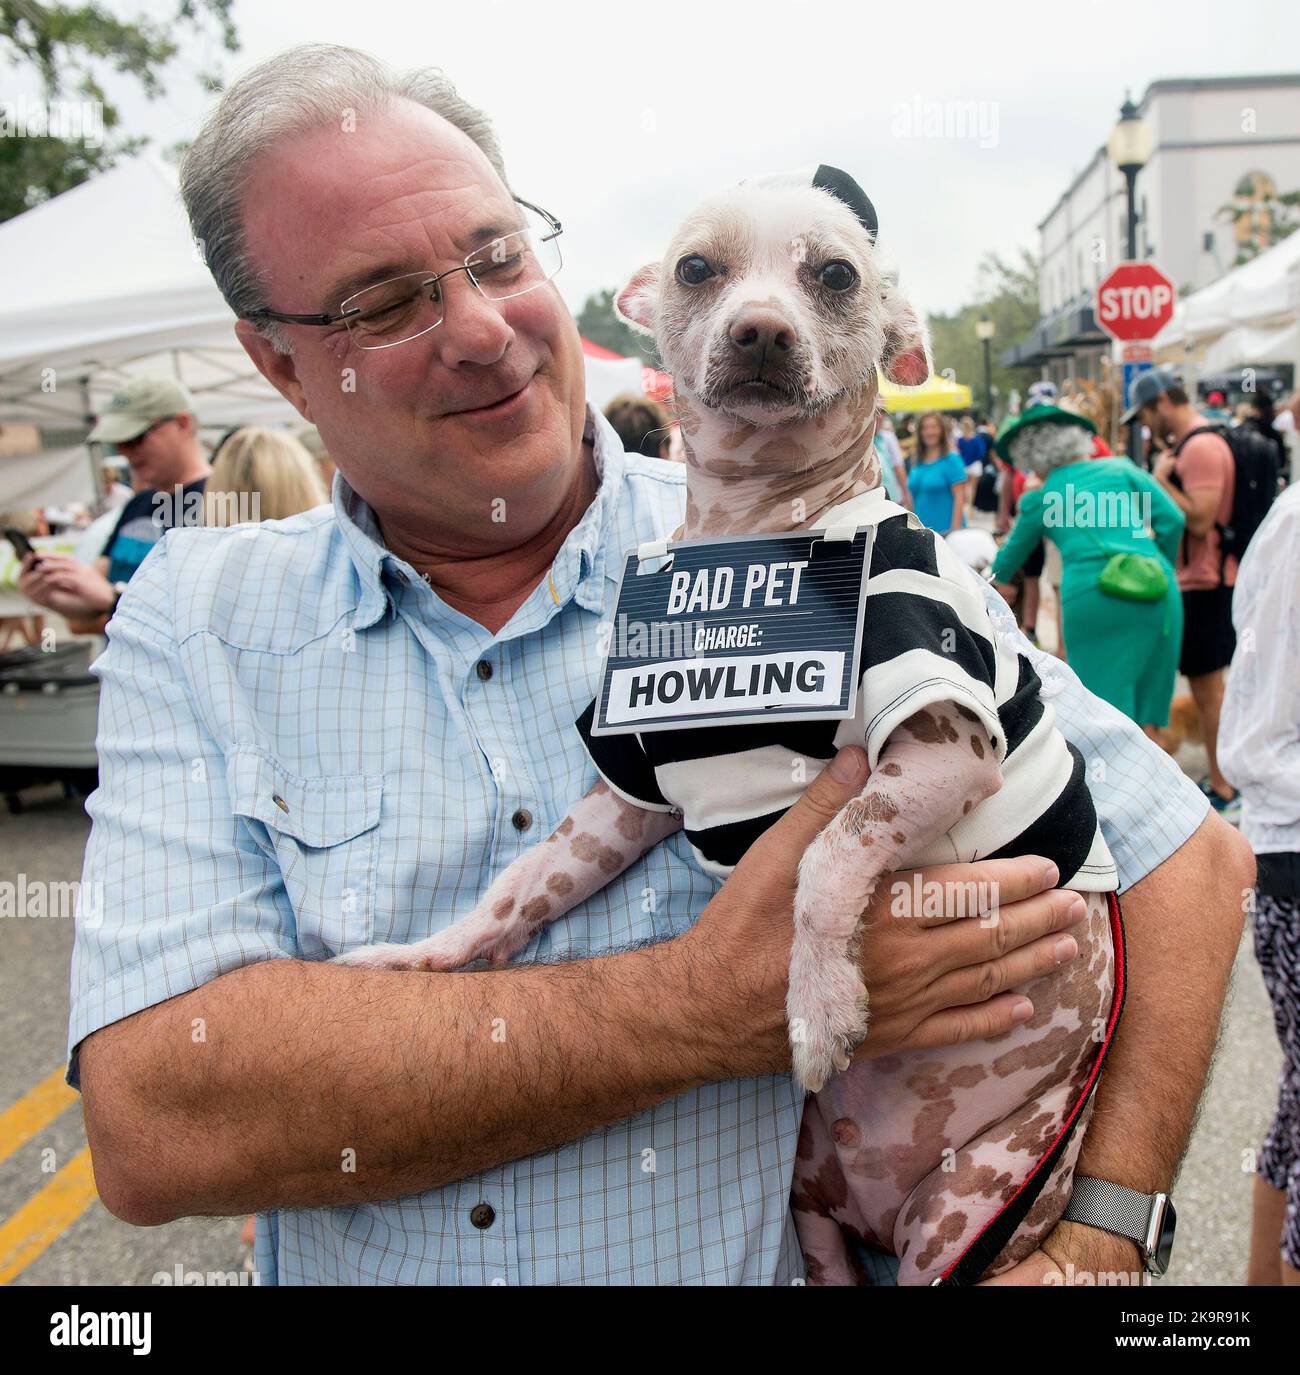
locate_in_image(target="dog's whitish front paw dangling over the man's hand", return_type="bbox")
[786,942,867,1093]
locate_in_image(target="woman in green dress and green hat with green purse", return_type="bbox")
[992,406,1183,737]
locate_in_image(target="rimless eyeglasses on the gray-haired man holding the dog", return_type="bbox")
[245,195,564,349]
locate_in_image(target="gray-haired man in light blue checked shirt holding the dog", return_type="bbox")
[69,48,1253,1284]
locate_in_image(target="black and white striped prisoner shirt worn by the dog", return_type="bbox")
[578,488,1118,892]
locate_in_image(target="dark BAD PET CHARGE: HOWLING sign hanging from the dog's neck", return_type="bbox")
[592,525,875,736]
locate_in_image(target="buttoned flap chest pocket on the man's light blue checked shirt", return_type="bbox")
[226,751,384,960]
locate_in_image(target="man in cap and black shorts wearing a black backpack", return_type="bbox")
[1121,367,1277,820]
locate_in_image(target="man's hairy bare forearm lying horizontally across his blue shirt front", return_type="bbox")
[81,941,758,1225]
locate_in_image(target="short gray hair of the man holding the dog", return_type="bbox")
[180,43,506,353]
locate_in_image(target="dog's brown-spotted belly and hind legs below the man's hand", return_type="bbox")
[791,892,1114,1284]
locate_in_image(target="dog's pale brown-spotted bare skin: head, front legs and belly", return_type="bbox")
[340,177,1114,1284]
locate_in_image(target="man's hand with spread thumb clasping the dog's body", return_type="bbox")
[674,747,1087,1075]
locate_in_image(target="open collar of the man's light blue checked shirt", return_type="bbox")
[332,404,623,630]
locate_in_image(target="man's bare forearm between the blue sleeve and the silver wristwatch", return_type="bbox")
[1077,815,1255,1194]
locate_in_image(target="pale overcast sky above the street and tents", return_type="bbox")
[10,0,1300,319]
